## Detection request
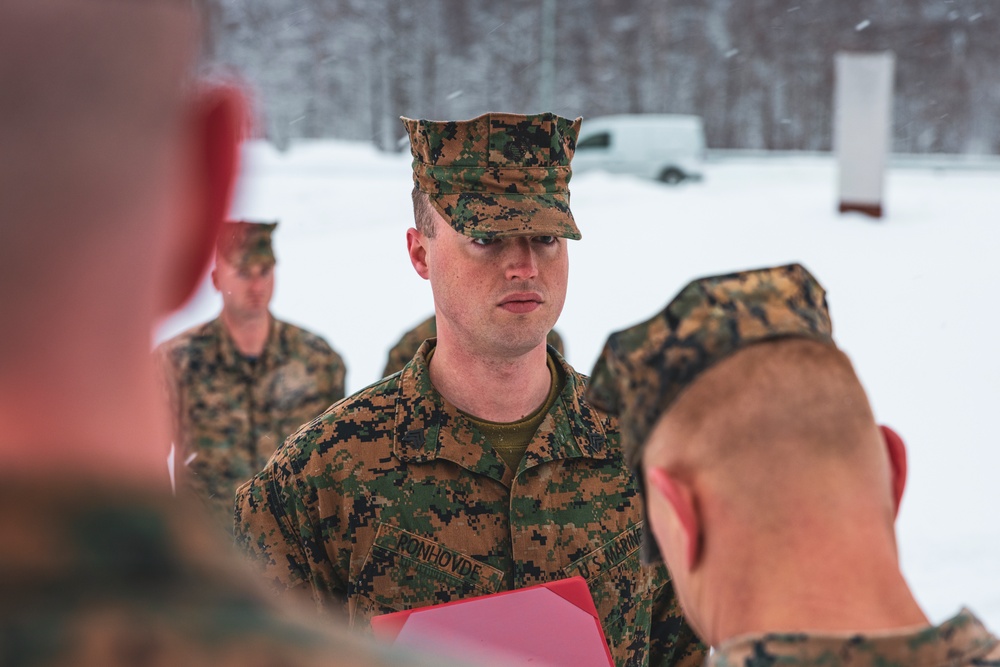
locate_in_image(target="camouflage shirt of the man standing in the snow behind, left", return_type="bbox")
[157,318,345,531]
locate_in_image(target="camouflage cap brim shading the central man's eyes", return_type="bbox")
[428,192,581,240]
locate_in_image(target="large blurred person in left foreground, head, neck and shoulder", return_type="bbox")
[0,0,422,665]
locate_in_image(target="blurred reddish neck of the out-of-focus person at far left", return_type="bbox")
[0,312,170,490]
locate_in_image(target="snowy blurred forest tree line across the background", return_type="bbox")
[206,0,1000,154]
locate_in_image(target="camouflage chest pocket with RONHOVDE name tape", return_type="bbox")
[351,523,504,625]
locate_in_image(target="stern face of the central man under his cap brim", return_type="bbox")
[425,218,569,356]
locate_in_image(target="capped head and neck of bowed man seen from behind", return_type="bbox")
[590,265,948,646]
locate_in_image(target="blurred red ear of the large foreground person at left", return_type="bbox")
[165,86,246,312]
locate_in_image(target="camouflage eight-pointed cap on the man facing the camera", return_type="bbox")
[402,113,583,239]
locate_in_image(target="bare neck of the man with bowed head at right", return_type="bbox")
[699,525,929,646]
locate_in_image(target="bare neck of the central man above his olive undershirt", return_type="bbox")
[430,330,552,422]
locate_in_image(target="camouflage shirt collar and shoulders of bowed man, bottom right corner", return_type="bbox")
[706,609,1000,667]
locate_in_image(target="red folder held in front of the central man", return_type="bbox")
[372,577,614,667]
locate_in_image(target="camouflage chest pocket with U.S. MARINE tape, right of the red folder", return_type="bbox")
[563,523,669,666]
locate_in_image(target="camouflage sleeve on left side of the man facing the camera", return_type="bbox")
[233,454,346,609]
